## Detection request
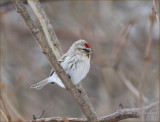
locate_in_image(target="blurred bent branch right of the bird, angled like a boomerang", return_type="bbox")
[110,19,148,102]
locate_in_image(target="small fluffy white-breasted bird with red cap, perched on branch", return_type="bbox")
[31,39,92,90]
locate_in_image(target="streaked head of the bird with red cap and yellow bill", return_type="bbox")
[70,39,92,60]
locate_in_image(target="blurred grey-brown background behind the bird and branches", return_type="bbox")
[0,0,159,120]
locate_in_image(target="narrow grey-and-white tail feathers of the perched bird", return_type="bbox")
[30,78,49,90]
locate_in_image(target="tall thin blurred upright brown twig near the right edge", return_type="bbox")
[139,0,157,121]
